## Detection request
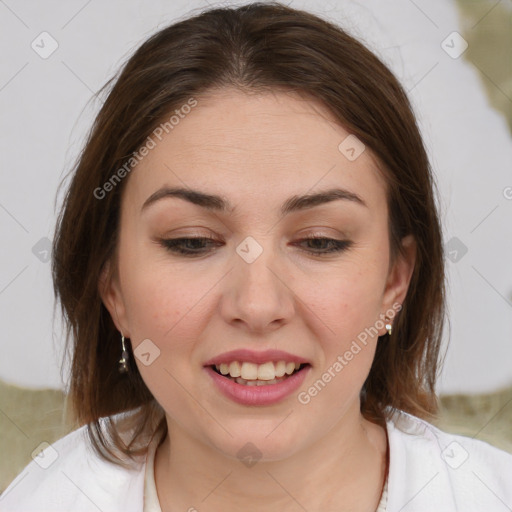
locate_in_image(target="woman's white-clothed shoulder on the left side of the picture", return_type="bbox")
[0,418,145,512]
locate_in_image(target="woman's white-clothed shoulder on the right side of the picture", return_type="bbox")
[387,410,512,512]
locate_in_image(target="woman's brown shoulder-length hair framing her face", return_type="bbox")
[52,2,445,463]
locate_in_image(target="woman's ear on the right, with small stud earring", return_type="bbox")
[379,235,416,336]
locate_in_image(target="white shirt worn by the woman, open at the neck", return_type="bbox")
[0,411,512,512]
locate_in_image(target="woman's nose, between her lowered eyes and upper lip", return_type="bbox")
[221,242,295,336]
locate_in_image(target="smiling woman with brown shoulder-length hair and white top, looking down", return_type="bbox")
[0,4,512,512]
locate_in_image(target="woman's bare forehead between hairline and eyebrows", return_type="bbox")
[125,90,385,214]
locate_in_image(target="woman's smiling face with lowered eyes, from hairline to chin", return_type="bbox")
[101,90,414,460]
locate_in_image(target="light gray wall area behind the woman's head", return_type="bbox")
[0,0,512,392]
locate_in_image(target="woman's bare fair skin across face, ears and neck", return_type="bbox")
[100,86,416,512]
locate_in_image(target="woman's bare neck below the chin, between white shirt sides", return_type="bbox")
[155,404,387,512]
